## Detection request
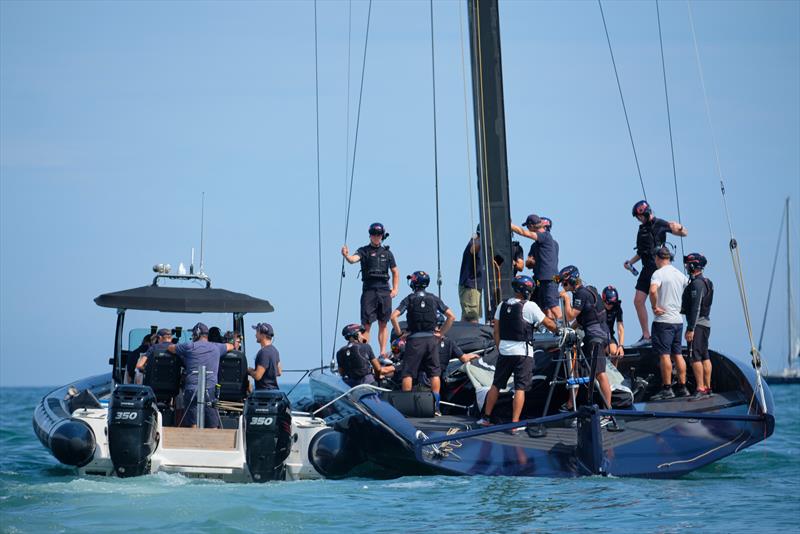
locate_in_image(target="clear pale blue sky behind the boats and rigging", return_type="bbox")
[0,0,800,386]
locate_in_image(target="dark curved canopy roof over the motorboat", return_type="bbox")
[94,285,275,313]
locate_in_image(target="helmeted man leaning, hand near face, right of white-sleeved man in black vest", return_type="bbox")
[558,265,611,408]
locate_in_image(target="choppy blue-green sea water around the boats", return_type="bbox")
[0,385,800,533]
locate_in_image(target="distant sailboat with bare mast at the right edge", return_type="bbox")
[759,197,800,384]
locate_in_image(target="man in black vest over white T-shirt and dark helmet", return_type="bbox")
[478,276,557,433]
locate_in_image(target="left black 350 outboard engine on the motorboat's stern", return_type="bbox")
[108,385,158,477]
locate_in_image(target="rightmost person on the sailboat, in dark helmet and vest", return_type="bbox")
[681,252,714,399]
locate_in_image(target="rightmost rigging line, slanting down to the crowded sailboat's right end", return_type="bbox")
[684,0,767,413]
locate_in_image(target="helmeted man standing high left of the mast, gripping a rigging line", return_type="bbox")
[342,223,400,356]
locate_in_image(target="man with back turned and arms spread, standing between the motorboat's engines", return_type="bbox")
[166,323,233,428]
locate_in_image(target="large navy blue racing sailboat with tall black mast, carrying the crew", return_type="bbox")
[309,0,775,478]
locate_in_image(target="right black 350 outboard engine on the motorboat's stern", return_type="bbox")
[244,389,292,482]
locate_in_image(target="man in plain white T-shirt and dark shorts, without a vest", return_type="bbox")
[650,247,689,400]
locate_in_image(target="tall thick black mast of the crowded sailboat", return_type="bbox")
[467,0,513,319]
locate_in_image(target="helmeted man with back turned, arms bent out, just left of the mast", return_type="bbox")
[391,271,456,413]
